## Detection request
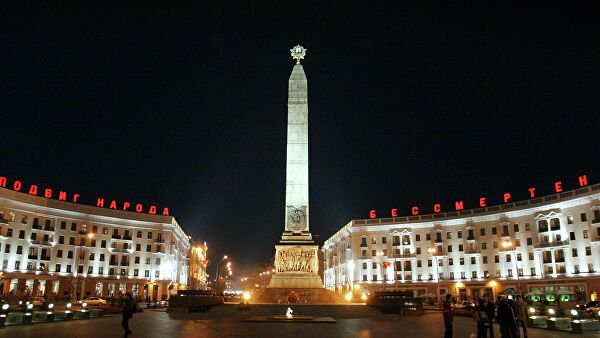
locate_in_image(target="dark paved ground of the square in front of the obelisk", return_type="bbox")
[0,305,600,338]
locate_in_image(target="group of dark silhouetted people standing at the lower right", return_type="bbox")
[442,294,527,338]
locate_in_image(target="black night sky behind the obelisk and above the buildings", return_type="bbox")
[0,2,600,271]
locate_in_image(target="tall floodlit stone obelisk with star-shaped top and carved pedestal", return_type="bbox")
[269,45,323,288]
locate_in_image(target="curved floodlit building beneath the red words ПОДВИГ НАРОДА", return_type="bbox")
[0,188,190,300]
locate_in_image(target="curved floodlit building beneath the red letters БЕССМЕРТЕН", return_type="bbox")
[322,184,600,301]
